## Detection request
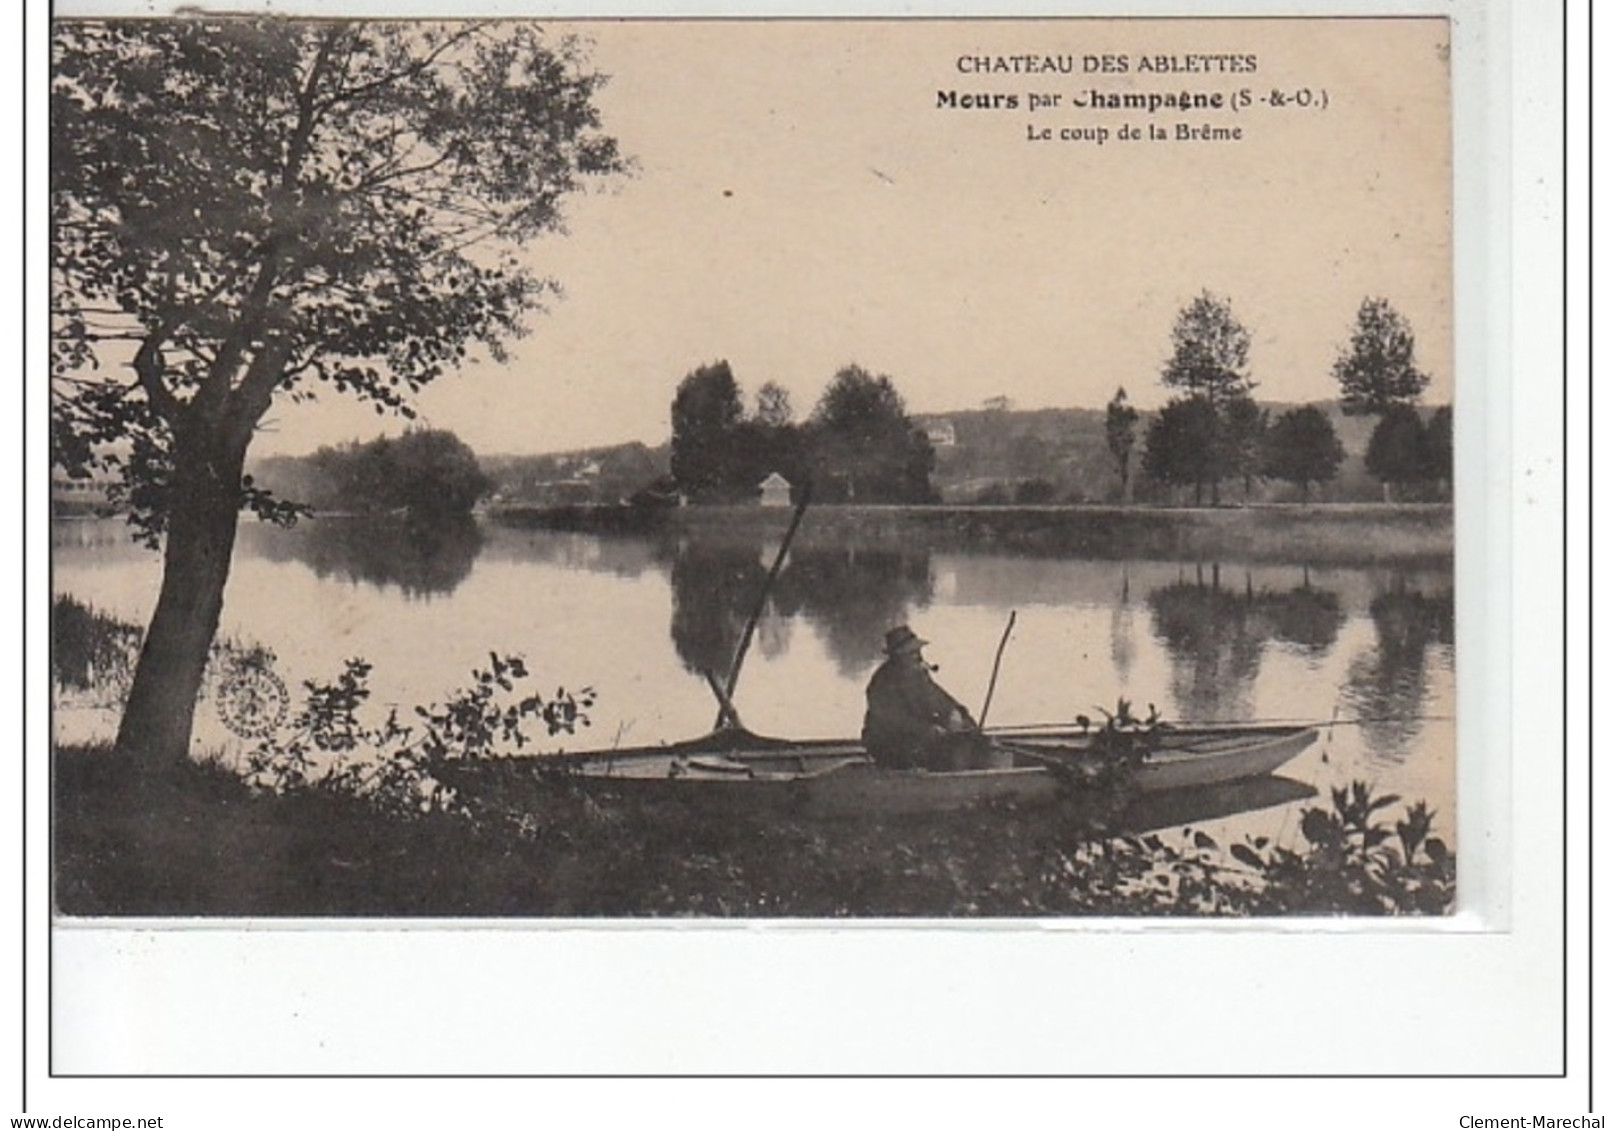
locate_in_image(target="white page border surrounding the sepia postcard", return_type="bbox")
[15,2,1586,1126]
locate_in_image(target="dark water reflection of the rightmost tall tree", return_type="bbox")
[1345,578,1454,763]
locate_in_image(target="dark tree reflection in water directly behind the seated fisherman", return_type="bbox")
[775,548,932,677]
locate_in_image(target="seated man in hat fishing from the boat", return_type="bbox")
[864,625,984,769]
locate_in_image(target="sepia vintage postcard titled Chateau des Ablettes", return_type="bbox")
[50,16,1466,921]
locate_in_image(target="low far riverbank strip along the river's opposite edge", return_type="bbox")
[488,502,1454,566]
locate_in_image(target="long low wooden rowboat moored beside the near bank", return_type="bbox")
[433,724,1318,818]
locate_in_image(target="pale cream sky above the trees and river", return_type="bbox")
[245,19,1454,454]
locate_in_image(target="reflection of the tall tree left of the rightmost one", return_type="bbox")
[1150,567,1266,719]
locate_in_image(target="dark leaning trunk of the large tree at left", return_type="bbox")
[118,433,245,767]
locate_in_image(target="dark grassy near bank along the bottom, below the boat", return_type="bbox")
[53,748,1455,918]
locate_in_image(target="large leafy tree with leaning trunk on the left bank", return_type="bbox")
[50,16,625,761]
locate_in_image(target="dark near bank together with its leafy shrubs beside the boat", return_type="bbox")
[57,636,1457,916]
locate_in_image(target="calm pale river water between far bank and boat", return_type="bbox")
[53,519,1454,837]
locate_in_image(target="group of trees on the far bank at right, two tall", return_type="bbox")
[1105,292,1452,506]
